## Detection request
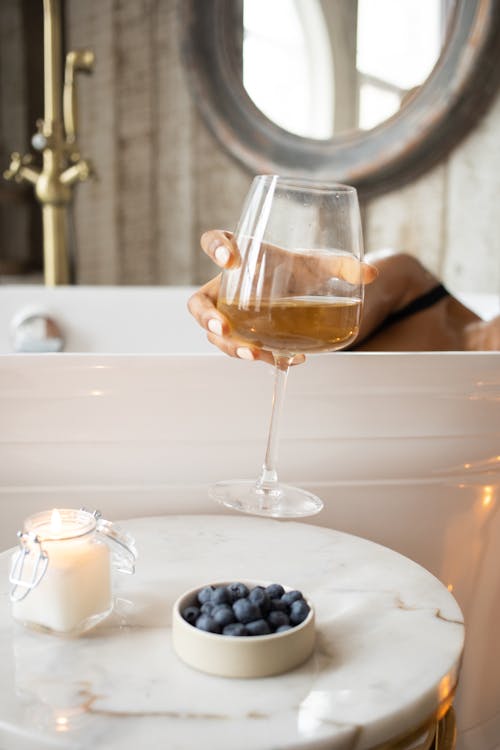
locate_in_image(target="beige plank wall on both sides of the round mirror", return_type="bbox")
[4,0,500,293]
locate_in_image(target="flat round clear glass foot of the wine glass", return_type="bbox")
[208,480,323,518]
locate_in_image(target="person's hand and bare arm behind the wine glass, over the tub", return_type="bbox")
[189,230,500,356]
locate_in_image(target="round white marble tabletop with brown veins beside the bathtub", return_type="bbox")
[0,515,464,750]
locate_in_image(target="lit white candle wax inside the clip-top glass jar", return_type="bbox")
[12,510,112,634]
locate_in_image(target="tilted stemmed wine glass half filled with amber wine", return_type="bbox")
[209,175,363,518]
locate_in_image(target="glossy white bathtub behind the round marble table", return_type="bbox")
[0,287,500,750]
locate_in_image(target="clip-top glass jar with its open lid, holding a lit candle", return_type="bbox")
[9,508,136,635]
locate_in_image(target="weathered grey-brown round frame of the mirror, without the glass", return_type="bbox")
[178,0,500,197]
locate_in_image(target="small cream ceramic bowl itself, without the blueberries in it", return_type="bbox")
[172,581,315,677]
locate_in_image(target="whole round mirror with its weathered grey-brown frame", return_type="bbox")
[179,0,500,195]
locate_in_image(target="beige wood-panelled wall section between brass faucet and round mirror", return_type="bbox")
[67,0,250,284]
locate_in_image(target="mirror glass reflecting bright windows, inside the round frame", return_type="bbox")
[243,0,454,139]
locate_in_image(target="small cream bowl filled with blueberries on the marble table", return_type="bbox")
[172,581,315,677]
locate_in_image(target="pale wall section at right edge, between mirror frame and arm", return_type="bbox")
[365,89,500,296]
